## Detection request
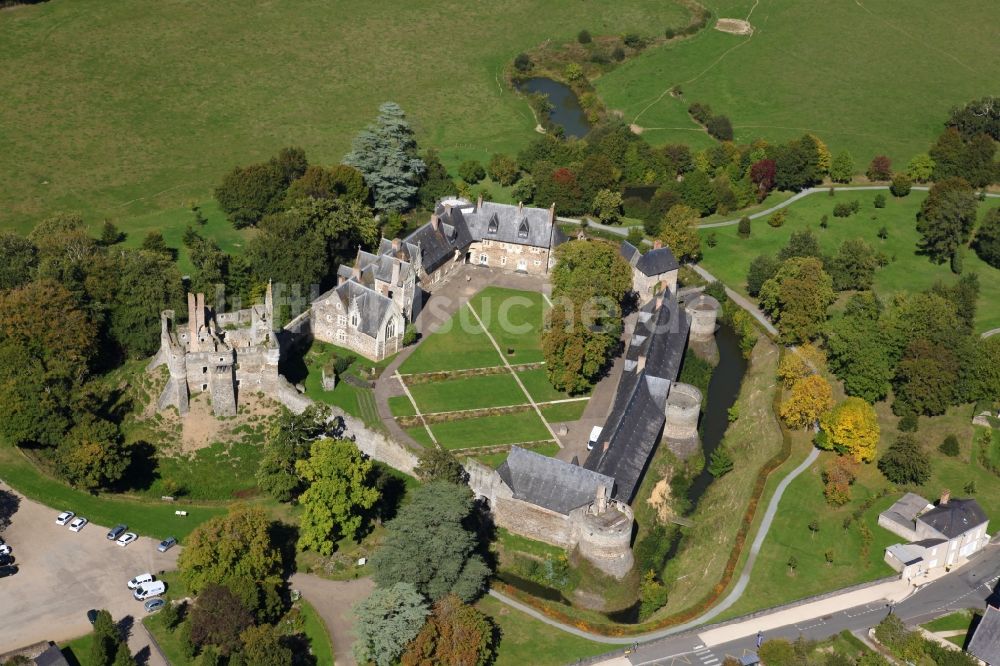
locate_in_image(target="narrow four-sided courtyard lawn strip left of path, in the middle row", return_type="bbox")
[409,372,528,414]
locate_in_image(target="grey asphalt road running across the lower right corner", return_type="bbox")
[616,544,1000,666]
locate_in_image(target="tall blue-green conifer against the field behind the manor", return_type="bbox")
[344,102,426,211]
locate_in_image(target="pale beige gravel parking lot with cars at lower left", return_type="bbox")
[0,485,180,654]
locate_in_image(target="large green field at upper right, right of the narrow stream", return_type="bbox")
[596,0,1000,164]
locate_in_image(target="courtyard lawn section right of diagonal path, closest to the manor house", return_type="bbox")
[471,287,547,363]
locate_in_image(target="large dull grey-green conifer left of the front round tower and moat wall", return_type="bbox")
[371,481,489,601]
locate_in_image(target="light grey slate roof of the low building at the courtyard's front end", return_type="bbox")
[497,446,615,515]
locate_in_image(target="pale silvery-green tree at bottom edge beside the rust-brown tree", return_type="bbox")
[354,583,428,666]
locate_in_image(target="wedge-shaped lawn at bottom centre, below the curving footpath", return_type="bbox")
[476,597,614,666]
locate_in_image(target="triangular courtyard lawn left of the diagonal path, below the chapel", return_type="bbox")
[399,305,503,374]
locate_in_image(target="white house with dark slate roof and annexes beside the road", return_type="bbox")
[878,491,990,580]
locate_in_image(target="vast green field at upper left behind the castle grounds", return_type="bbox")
[0,0,688,231]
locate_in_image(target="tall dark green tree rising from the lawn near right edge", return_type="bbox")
[917,178,977,264]
